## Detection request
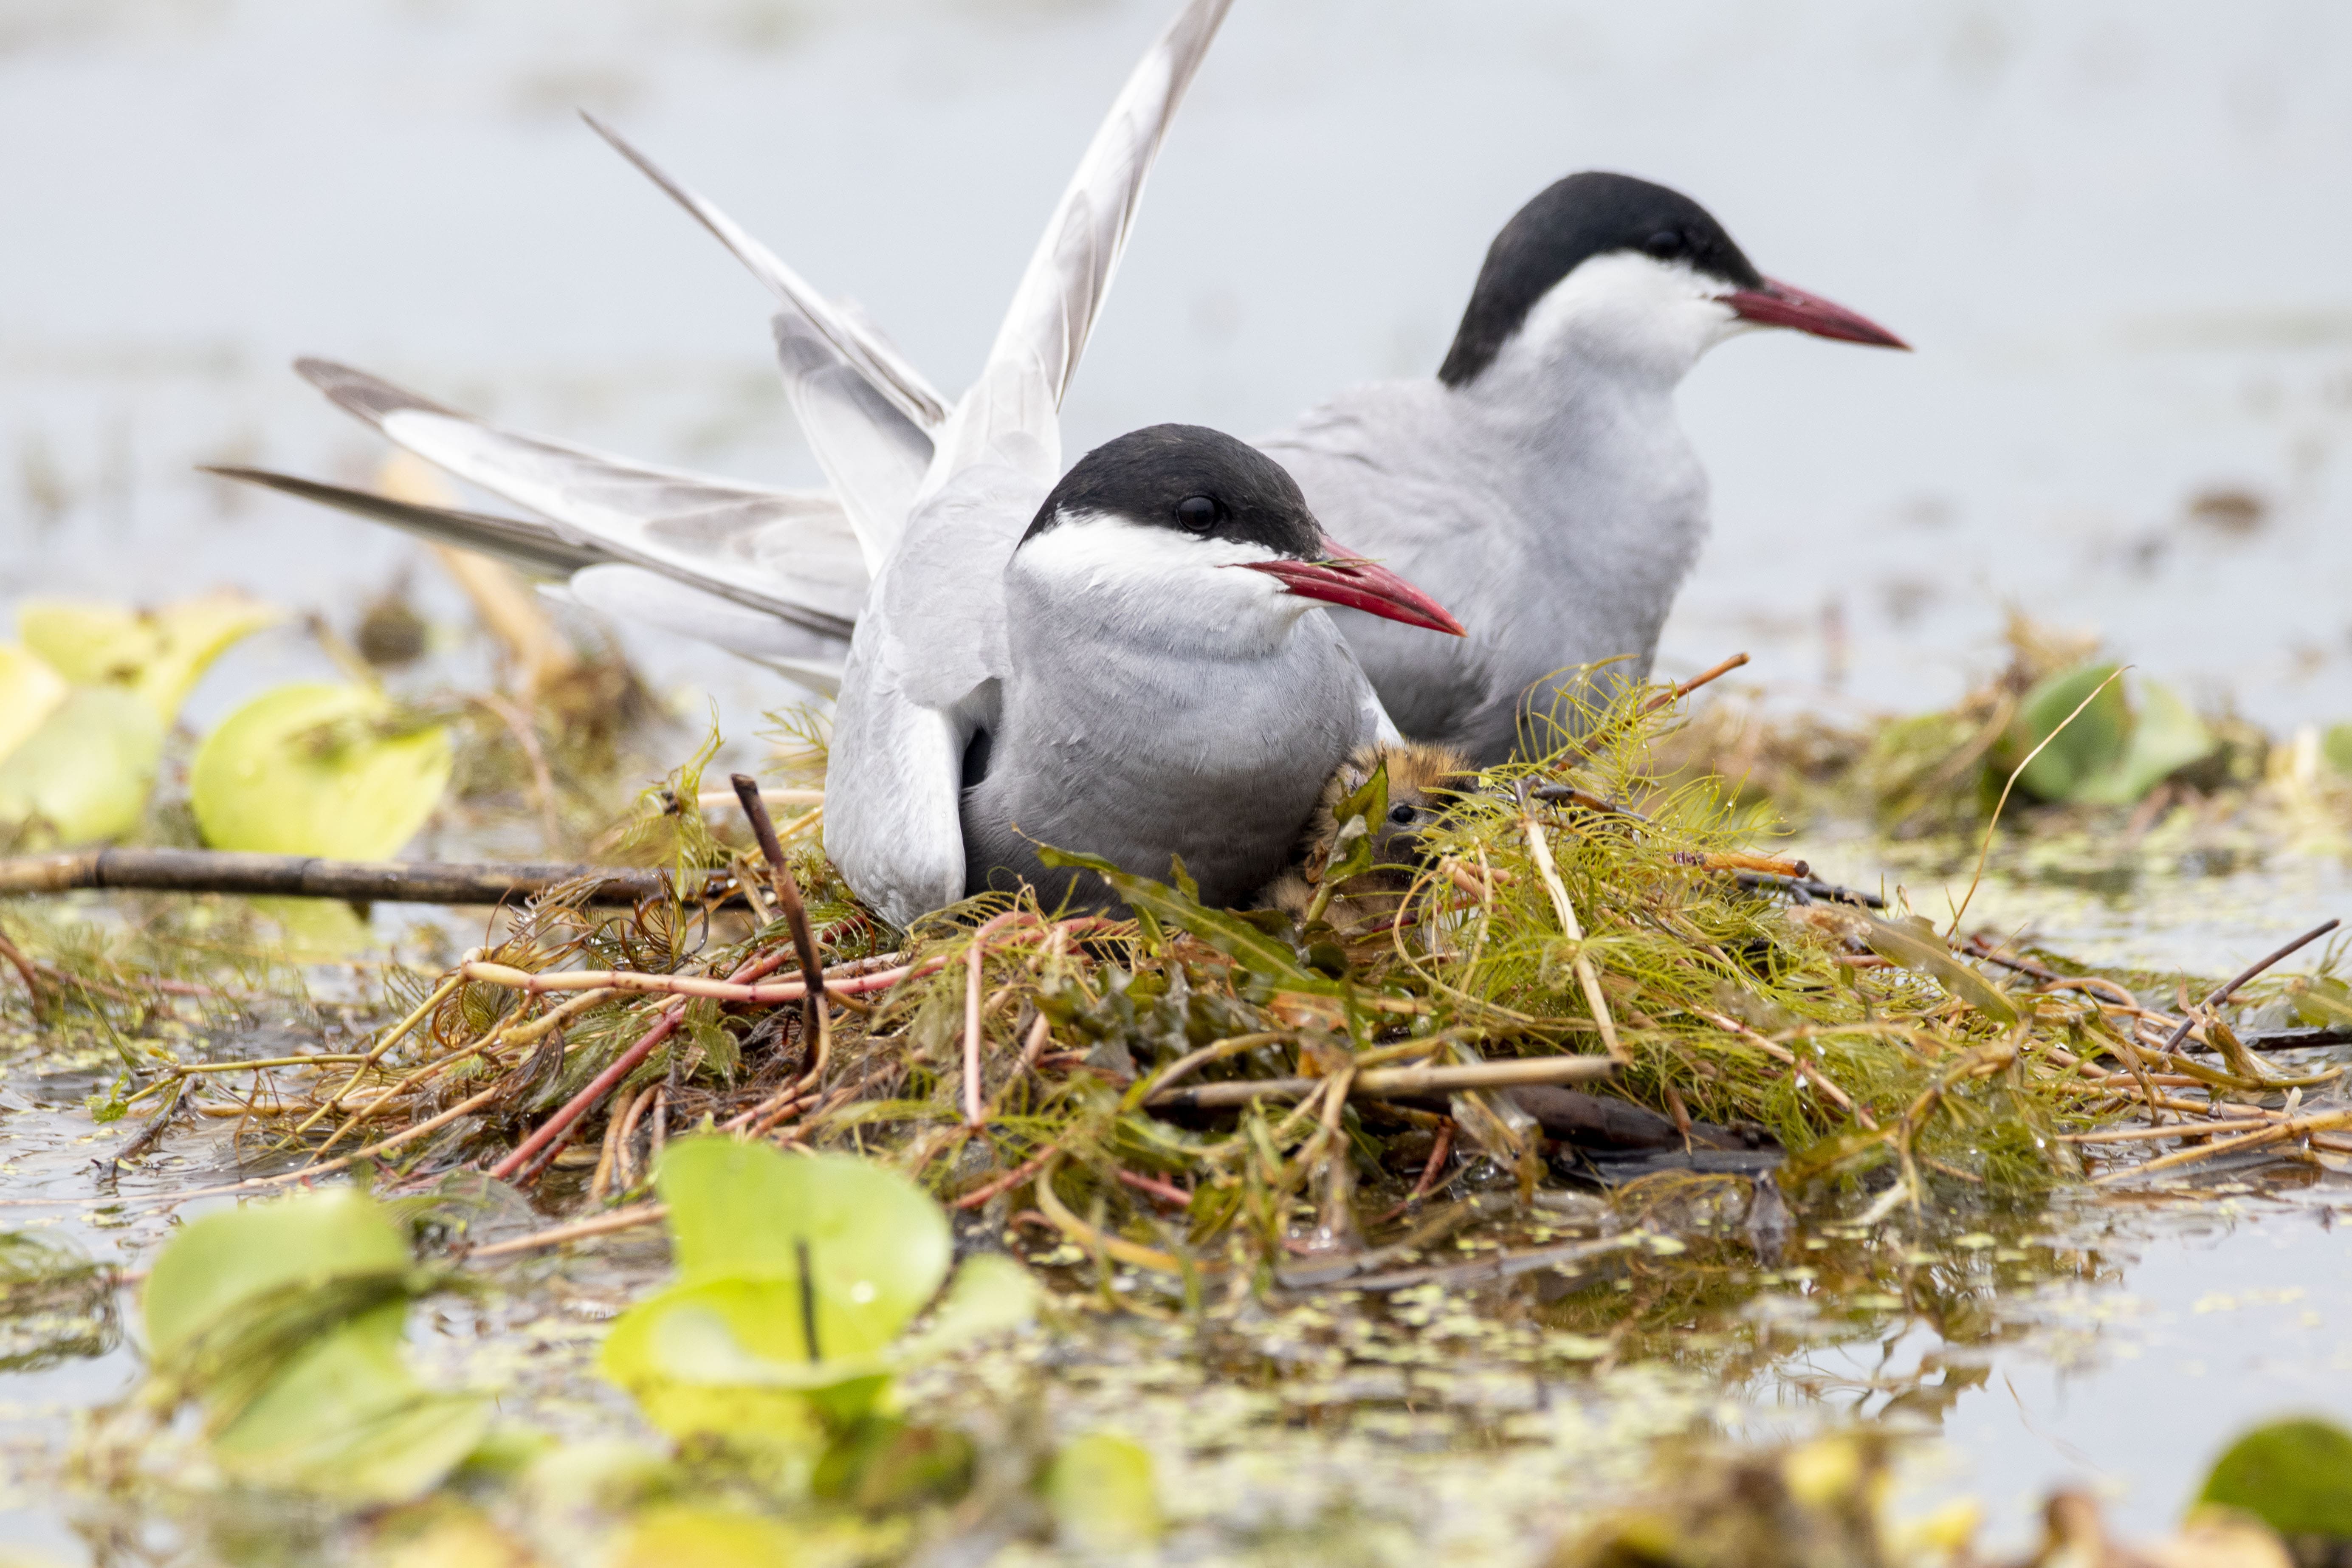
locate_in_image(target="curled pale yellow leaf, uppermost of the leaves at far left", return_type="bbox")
[17,592,285,726]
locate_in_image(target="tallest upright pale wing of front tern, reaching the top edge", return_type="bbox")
[924,0,1232,489]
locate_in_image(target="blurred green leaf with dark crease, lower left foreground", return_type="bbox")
[144,1190,491,1502]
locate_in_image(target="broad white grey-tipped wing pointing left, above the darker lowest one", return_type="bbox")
[294,360,868,637]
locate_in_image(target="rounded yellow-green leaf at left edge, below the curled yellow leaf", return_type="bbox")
[0,686,165,844]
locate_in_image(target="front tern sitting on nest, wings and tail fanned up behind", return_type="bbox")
[212,0,1461,926]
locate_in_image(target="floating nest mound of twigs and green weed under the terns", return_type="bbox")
[12,691,2352,1279]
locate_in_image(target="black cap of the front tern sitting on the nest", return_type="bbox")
[1021,426,1324,559]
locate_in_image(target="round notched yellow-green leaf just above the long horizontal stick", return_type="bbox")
[188,682,451,860]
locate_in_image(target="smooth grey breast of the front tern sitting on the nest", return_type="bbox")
[964,604,1367,905]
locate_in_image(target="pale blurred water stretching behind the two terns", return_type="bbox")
[0,0,2352,726]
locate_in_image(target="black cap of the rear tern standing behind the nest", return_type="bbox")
[1437,174,1764,386]
